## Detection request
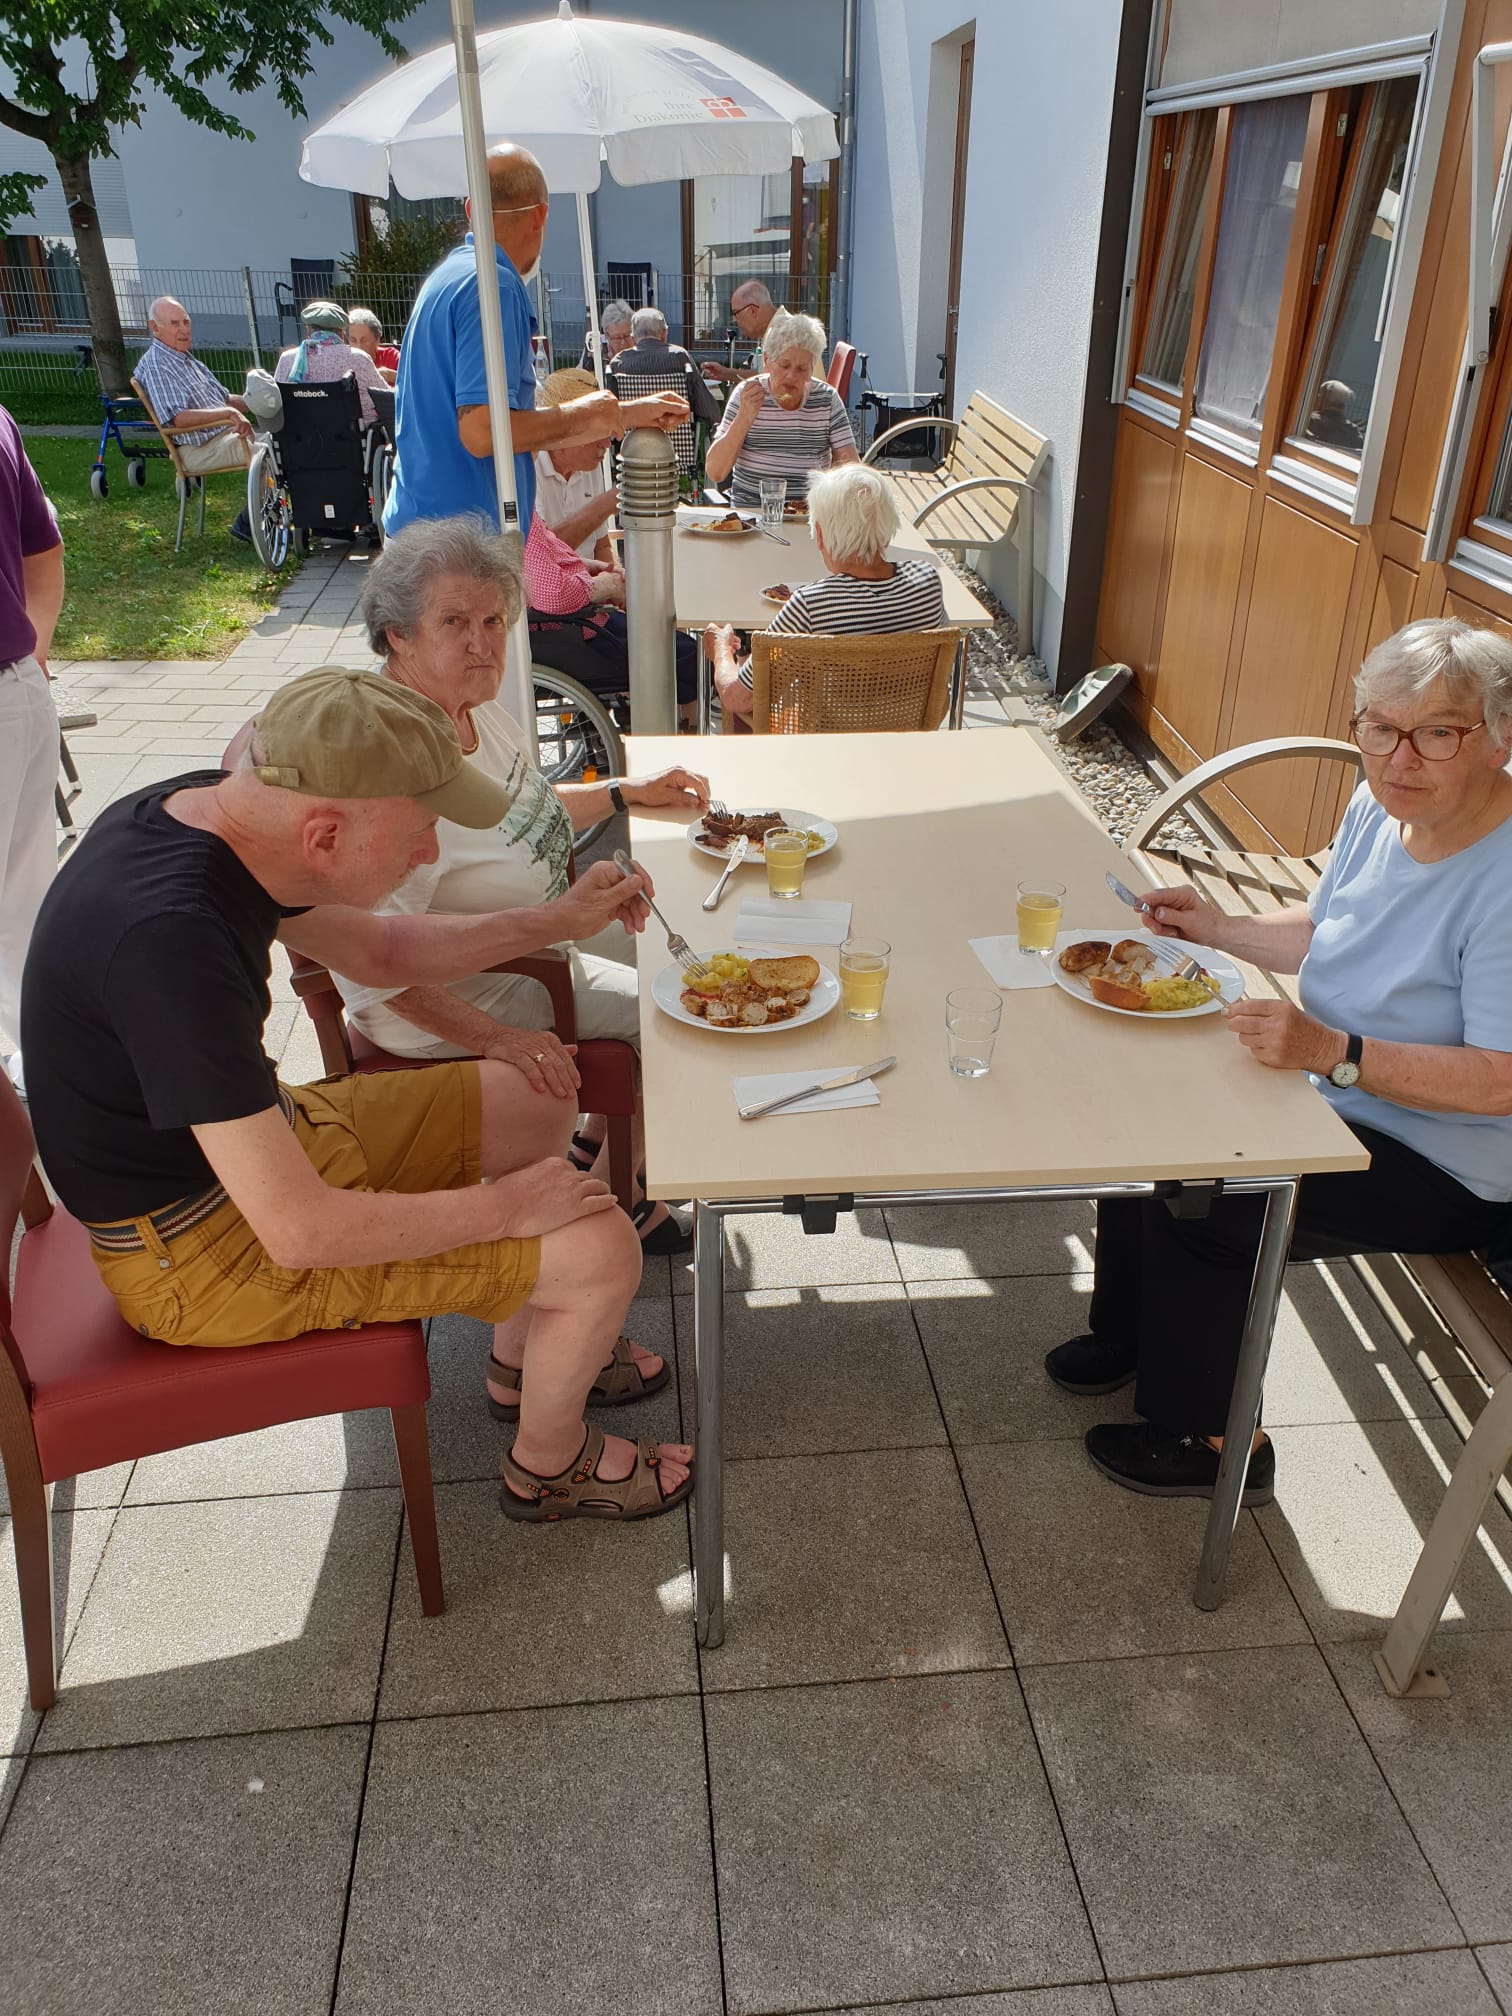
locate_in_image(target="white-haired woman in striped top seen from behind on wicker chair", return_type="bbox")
[704,464,946,726]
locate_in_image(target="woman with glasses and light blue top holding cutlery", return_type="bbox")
[1044,617,1512,1506]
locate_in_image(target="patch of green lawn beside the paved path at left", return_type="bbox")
[26,433,298,657]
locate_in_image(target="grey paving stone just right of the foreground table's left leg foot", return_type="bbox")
[705,1450,1008,1689]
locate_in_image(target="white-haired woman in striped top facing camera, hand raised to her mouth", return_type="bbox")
[704,308,861,510]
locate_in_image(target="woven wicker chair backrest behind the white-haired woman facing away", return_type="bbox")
[750,629,962,736]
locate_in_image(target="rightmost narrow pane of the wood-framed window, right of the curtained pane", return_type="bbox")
[1294,77,1417,462]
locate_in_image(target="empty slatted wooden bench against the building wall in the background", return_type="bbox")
[863,391,1050,651]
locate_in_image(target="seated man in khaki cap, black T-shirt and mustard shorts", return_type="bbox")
[22,667,691,1520]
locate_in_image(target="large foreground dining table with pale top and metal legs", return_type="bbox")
[629,728,1369,1645]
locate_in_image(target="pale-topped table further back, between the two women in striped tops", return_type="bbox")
[671,504,992,734]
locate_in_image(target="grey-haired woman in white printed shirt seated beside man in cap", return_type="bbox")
[337,518,708,1254]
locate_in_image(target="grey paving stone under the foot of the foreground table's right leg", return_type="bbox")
[960,1439,1310,1665]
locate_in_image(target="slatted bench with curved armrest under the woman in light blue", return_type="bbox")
[1125,736,1512,1695]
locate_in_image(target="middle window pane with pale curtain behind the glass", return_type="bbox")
[1193,97,1310,442]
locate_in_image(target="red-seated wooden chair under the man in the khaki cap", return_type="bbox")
[0,1075,444,1712]
